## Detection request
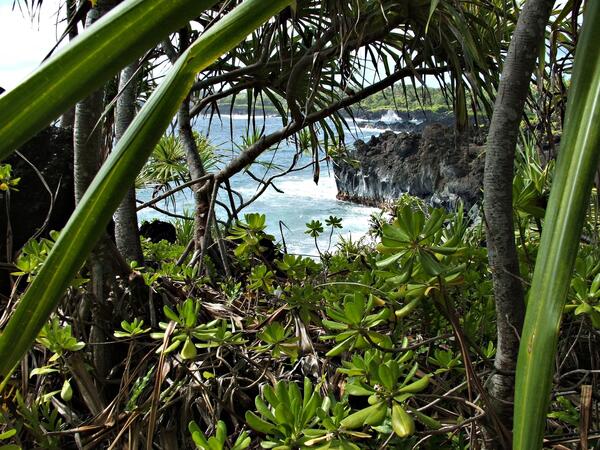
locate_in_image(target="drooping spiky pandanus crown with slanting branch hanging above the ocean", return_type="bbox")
[138,0,508,258]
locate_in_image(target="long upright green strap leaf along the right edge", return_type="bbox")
[513,1,600,450]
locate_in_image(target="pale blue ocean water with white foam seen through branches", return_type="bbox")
[138,115,387,256]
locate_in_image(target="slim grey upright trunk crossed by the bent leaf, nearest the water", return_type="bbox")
[114,63,143,263]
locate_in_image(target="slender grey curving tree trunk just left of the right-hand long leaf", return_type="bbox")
[484,0,554,440]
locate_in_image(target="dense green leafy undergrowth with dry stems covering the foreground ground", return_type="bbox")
[0,142,600,450]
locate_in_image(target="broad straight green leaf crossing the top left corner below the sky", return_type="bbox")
[0,0,218,160]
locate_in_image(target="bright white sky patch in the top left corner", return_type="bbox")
[0,0,65,89]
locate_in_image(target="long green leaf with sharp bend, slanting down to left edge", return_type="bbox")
[0,0,291,375]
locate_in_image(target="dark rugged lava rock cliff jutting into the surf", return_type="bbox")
[334,123,484,208]
